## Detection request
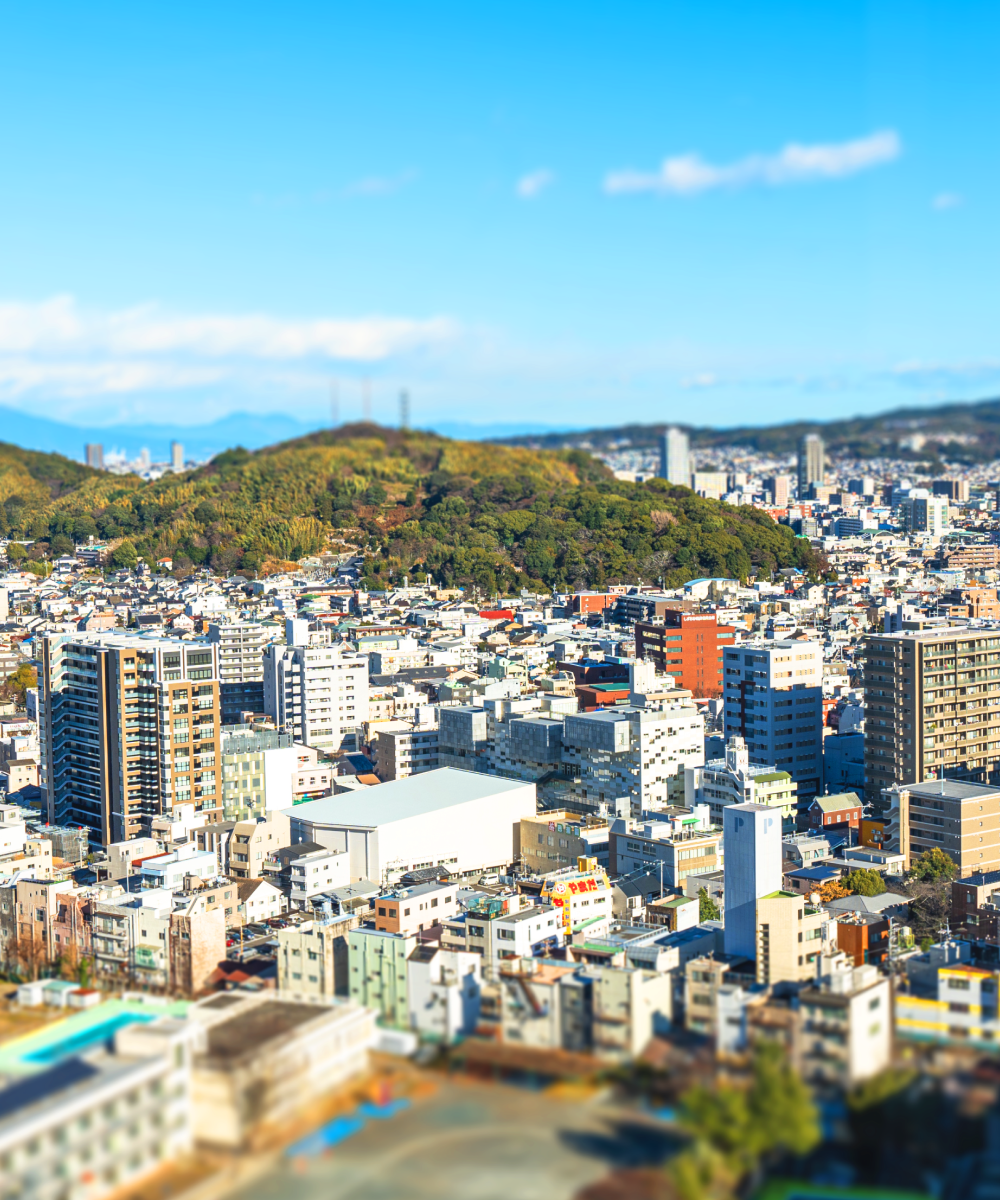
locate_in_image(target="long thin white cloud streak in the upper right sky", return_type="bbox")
[604,130,903,196]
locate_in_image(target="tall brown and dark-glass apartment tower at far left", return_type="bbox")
[38,632,222,846]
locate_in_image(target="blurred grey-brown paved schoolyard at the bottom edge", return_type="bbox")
[238,1080,670,1200]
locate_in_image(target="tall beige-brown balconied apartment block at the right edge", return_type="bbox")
[862,625,1000,811]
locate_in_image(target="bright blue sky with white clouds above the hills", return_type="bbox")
[0,0,1000,436]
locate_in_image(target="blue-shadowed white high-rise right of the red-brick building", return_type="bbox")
[723,641,822,800]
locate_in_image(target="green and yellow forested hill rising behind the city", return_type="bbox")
[0,425,824,593]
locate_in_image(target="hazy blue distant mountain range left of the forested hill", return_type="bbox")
[0,408,318,462]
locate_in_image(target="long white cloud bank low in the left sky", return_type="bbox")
[0,295,455,362]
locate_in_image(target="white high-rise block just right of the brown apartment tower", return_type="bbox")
[264,620,369,750]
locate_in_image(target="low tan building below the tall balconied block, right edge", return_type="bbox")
[882,779,1000,877]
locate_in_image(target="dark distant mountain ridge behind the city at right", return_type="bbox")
[493,400,1000,464]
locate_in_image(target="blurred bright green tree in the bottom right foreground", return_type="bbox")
[675,1042,821,1180]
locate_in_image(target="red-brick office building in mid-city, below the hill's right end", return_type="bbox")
[635,608,736,698]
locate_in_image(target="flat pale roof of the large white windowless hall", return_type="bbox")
[282,767,533,829]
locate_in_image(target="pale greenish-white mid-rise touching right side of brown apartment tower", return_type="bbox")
[221,726,299,821]
